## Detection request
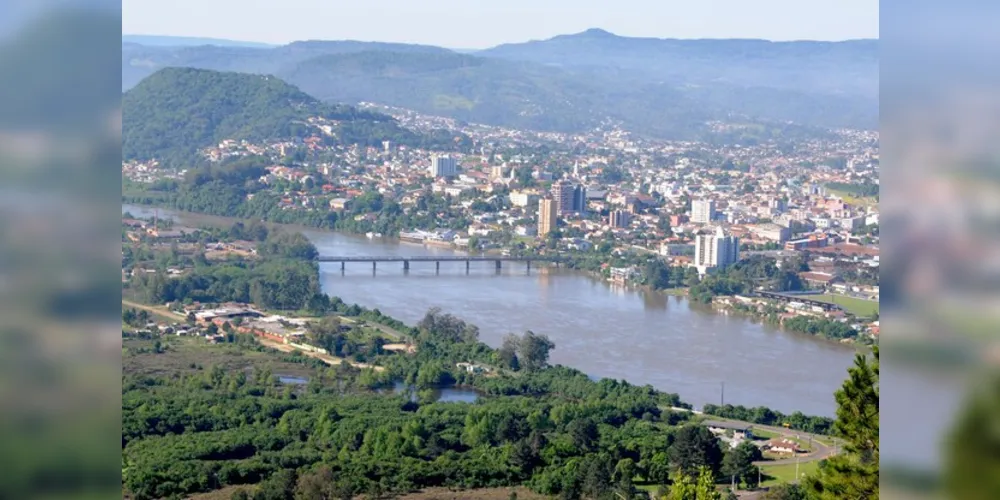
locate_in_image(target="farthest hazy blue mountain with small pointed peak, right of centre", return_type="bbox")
[476,29,879,99]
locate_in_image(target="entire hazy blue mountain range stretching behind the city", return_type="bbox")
[122,30,878,139]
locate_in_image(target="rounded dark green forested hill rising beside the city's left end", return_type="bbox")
[122,68,464,165]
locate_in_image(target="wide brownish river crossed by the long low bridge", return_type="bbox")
[122,201,855,416]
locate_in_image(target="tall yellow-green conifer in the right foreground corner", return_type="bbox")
[805,347,879,499]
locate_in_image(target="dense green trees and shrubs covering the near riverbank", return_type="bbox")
[122,228,878,500]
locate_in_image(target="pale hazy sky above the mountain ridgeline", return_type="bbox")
[122,0,879,48]
